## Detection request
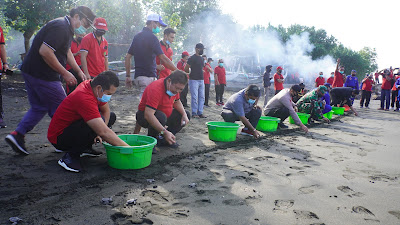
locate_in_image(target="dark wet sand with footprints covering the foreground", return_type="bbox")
[0,74,400,224]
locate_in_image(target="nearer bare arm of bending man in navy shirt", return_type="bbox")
[39,44,77,85]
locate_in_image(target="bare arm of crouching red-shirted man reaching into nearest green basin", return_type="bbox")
[87,118,129,146]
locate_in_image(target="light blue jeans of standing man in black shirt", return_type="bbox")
[189,80,205,116]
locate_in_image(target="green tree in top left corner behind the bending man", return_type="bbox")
[3,0,73,53]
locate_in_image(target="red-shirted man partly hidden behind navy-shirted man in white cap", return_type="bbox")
[156,28,176,79]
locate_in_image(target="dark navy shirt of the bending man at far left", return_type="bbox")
[21,16,74,81]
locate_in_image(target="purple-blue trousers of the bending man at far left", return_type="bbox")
[16,73,67,135]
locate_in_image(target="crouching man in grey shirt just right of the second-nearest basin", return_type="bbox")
[221,84,261,138]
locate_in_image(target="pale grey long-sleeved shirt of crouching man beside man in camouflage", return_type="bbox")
[264,88,301,125]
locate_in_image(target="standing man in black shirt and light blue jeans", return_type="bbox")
[185,43,207,118]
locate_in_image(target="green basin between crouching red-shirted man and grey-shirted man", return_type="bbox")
[206,121,239,142]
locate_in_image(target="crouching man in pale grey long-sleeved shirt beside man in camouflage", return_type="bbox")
[264,84,308,133]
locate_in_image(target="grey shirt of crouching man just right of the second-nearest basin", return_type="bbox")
[223,89,254,117]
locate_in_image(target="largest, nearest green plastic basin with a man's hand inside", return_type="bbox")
[103,134,157,170]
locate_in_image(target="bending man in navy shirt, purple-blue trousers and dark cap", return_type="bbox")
[5,6,96,155]
